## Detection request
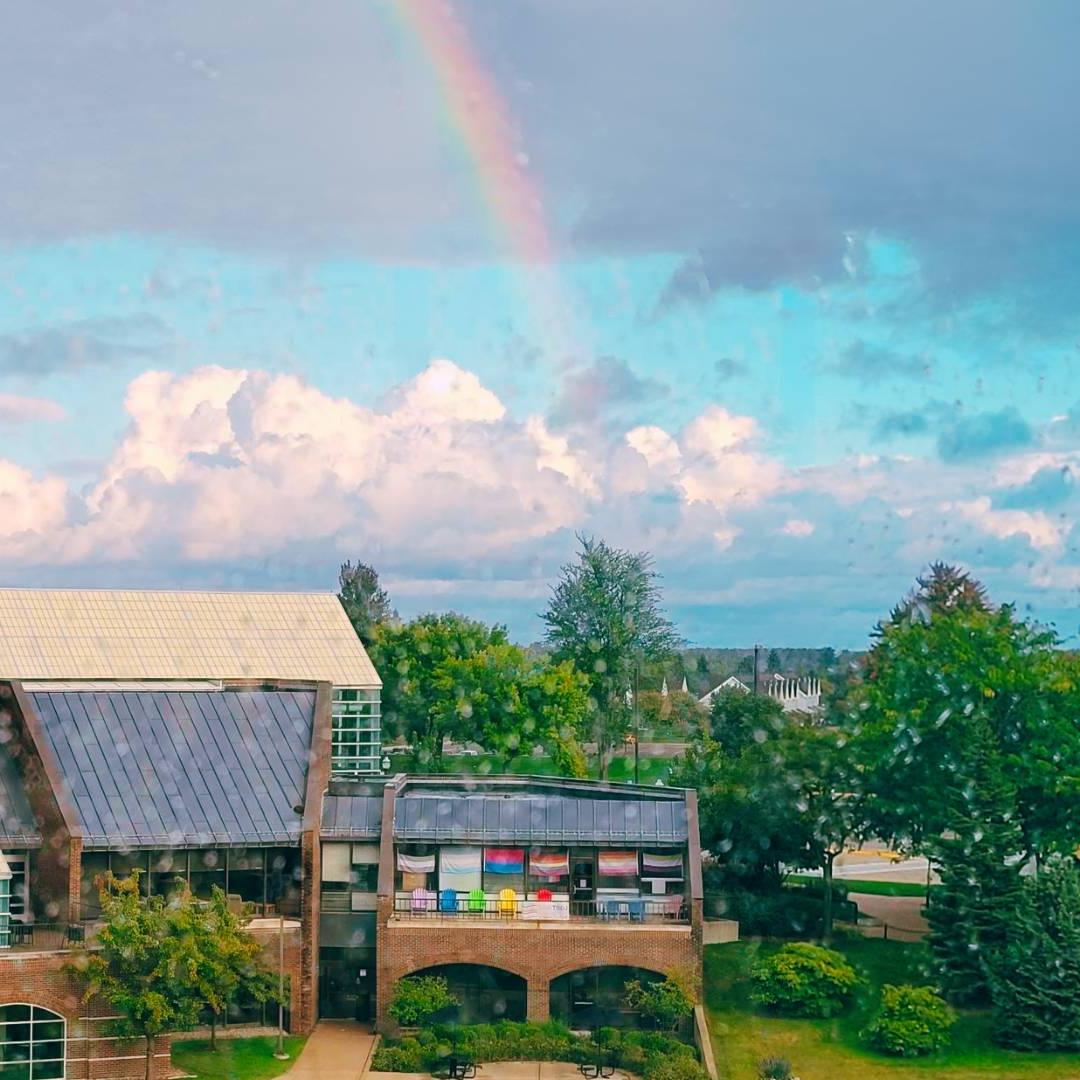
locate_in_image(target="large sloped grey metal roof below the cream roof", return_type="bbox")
[29,690,315,848]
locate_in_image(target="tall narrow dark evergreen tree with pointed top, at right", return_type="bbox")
[927,727,1023,1004]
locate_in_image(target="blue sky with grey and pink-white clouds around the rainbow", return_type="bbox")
[0,0,1080,646]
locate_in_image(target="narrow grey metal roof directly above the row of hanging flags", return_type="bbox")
[394,793,688,845]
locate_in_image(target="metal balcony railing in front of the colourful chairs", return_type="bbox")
[394,896,688,924]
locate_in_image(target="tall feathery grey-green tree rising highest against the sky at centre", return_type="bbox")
[543,537,678,773]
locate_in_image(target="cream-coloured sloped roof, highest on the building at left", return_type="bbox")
[0,589,380,688]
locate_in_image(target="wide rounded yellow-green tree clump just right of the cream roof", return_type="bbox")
[372,613,588,775]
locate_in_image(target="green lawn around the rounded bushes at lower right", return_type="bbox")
[705,939,1080,1080]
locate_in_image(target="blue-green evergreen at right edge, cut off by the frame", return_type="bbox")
[990,859,1080,1051]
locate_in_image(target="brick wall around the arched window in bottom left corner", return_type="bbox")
[0,953,172,1080]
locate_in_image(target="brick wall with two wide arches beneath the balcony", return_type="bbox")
[377,897,701,1030]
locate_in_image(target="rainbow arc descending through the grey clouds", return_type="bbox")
[388,0,571,358]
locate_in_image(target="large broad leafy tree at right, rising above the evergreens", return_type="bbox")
[846,568,1080,856]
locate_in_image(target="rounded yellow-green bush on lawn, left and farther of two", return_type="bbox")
[751,942,860,1017]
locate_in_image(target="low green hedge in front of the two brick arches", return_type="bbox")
[372,1021,708,1080]
